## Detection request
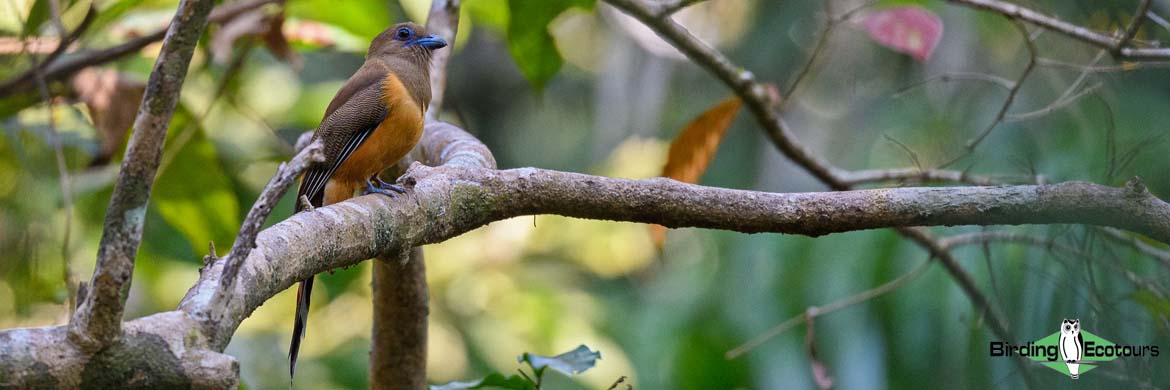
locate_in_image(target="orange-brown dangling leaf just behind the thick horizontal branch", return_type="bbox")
[651,96,742,248]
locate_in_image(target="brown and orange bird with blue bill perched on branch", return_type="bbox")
[289,22,447,377]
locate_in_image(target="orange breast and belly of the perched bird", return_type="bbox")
[332,73,424,185]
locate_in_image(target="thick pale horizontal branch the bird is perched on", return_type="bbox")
[0,117,1170,386]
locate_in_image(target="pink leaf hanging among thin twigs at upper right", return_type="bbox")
[861,7,943,62]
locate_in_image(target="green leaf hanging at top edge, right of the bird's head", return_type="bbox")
[508,0,594,90]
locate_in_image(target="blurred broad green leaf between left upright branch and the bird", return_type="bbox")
[151,114,240,251]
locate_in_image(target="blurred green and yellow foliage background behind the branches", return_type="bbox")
[0,0,1170,389]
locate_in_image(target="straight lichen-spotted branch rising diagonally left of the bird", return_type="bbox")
[69,0,214,349]
